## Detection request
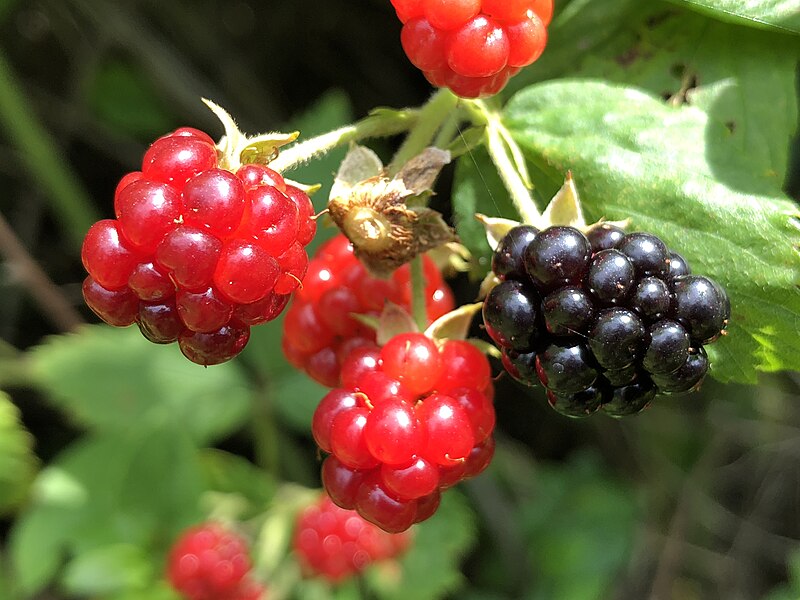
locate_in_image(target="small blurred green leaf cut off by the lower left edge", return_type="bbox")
[0,392,36,515]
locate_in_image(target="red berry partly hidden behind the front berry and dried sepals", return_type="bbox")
[283,235,454,387]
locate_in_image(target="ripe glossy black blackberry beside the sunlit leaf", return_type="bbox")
[483,224,730,417]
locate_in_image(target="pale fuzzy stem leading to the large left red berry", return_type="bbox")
[269,109,420,173]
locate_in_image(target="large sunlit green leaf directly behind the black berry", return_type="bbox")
[506,81,800,383]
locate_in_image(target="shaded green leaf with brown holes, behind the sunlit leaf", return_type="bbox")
[577,3,800,192]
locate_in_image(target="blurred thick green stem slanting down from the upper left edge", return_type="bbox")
[0,51,99,248]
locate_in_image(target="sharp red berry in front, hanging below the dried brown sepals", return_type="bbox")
[311,333,495,533]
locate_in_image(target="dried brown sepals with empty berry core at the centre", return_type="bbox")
[328,148,457,277]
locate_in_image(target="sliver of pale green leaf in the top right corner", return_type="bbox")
[672,0,800,34]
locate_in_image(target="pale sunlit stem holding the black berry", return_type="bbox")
[466,100,542,225]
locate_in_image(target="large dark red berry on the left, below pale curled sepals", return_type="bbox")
[81,127,316,365]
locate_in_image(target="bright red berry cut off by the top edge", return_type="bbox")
[391,0,553,98]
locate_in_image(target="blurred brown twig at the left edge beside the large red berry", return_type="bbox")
[0,214,84,331]
